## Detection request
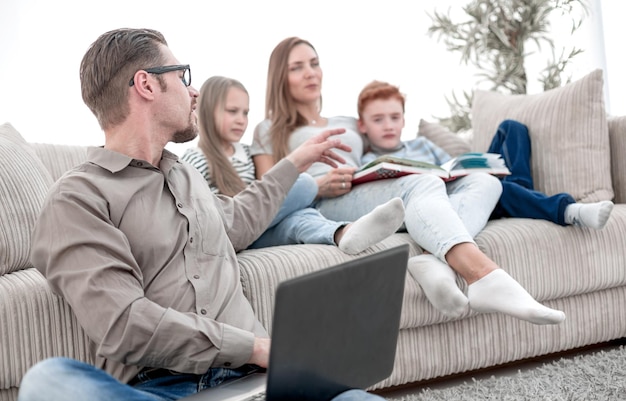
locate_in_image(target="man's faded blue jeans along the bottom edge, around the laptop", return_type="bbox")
[17,357,383,401]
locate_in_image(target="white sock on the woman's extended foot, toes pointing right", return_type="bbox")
[467,269,565,324]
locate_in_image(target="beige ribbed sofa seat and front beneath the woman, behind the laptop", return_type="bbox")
[239,208,626,389]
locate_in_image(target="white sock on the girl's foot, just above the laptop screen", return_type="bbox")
[338,198,404,255]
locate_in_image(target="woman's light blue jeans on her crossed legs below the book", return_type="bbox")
[315,173,502,261]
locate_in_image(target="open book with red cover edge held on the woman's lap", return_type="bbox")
[352,152,511,185]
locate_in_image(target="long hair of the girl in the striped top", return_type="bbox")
[198,76,248,196]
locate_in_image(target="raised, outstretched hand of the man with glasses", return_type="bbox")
[286,128,352,173]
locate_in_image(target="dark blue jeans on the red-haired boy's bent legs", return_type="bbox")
[487,120,575,226]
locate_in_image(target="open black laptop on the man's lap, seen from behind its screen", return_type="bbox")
[184,245,409,401]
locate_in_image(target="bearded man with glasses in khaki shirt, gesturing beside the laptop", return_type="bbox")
[18,29,379,401]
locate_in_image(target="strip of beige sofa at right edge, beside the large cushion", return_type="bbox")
[609,116,626,203]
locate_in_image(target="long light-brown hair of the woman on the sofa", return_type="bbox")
[265,37,317,162]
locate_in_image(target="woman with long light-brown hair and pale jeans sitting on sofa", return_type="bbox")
[252,37,565,324]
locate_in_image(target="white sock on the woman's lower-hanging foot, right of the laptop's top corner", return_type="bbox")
[408,254,468,318]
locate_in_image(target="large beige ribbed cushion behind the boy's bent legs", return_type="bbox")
[472,69,613,202]
